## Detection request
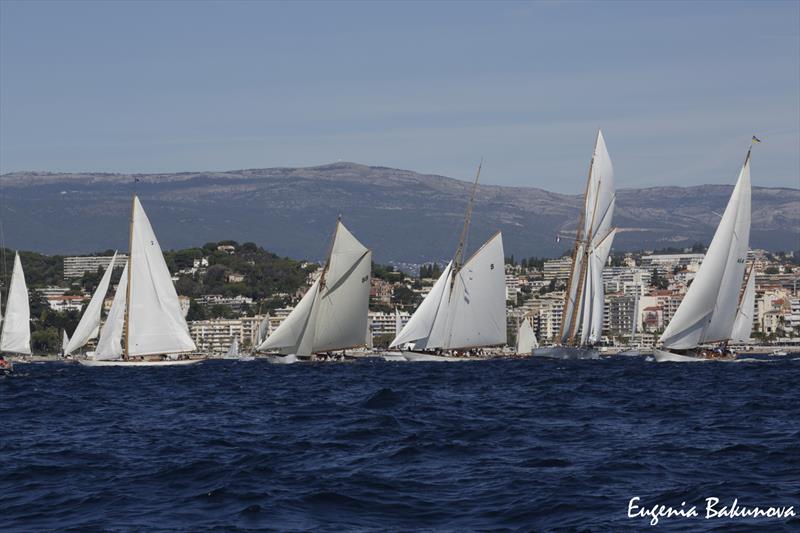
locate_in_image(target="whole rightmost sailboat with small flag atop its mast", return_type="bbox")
[653,147,755,362]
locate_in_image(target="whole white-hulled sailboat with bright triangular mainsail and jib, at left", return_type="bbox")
[80,195,198,366]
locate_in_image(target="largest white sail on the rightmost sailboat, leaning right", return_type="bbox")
[661,153,750,350]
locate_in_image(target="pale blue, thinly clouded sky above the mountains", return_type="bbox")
[0,0,800,193]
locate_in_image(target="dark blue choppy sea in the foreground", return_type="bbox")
[0,356,800,532]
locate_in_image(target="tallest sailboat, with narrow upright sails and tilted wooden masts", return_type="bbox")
[534,130,616,359]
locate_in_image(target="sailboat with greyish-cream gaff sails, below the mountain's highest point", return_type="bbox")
[257,220,372,362]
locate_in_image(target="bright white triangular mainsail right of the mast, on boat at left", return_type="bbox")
[127,197,197,356]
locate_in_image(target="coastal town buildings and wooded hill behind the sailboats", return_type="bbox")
[20,241,800,356]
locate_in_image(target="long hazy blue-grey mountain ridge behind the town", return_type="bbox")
[0,163,800,263]
